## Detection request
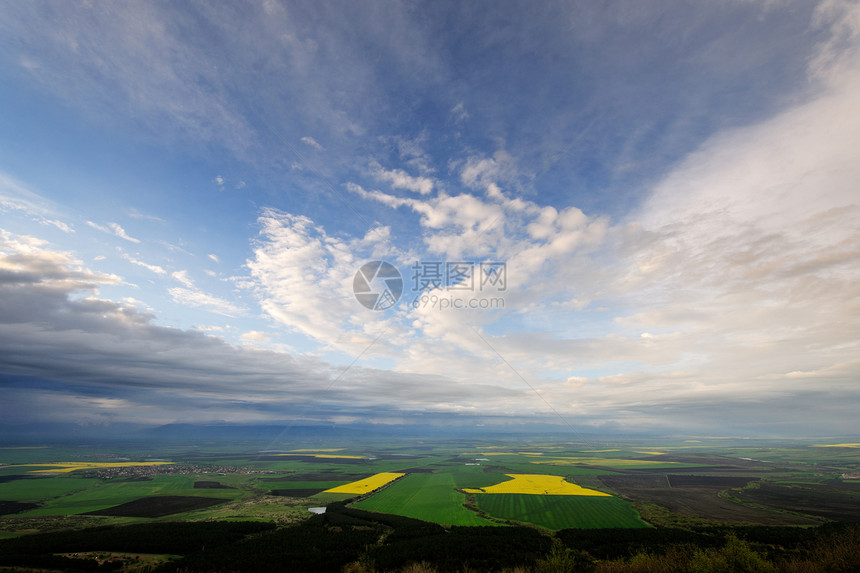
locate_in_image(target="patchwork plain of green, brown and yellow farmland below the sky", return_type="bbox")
[0,438,860,537]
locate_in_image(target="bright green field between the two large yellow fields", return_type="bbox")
[354,473,496,525]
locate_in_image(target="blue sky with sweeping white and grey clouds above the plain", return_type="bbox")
[0,0,860,436]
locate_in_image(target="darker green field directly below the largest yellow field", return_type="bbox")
[475,493,648,529]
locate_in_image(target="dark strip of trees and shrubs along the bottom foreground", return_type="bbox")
[0,503,860,573]
